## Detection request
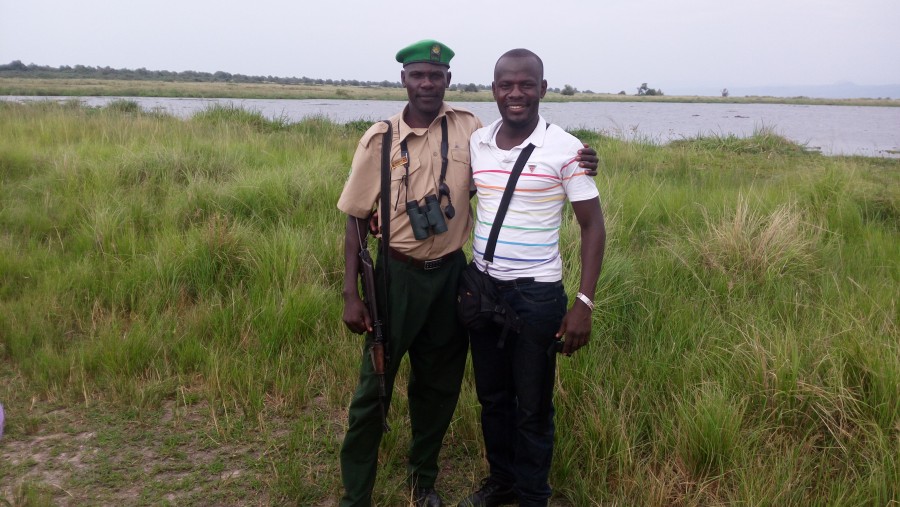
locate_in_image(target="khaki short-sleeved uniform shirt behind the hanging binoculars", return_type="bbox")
[338,102,481,260]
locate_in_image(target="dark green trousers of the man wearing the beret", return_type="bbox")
[340,251,468,507]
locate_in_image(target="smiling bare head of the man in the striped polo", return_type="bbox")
[491,50,547,133]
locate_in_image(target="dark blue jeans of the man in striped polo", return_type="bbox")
[469,279,567,506]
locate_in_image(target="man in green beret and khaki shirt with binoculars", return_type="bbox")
[338,40,597,507]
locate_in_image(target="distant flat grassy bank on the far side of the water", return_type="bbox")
[0,78,900,107]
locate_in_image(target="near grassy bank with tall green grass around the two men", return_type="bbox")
[0,102,900,506]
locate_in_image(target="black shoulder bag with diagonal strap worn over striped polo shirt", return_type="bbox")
[456,143,534,348]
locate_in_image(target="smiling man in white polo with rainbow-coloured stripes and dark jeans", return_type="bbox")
[460,49,606,506]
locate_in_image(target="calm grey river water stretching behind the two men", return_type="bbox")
[7,96,900,157]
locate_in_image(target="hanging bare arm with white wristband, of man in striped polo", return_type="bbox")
[556,197,606,355]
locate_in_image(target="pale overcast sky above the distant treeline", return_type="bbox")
[0,0,900,94]
